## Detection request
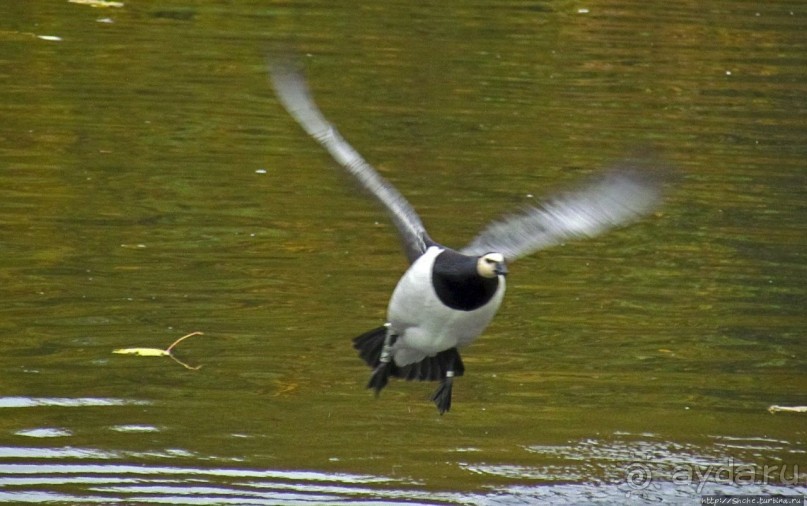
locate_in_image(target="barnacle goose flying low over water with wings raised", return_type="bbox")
[269,61,660,414]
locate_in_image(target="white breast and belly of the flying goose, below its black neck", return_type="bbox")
[387,246,505,366]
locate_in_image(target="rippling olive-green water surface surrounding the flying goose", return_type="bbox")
[0,1,807,504]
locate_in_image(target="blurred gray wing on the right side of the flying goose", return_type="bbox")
[462,170,661,261]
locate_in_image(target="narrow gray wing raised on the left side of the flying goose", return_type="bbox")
[269,61,432,263]
